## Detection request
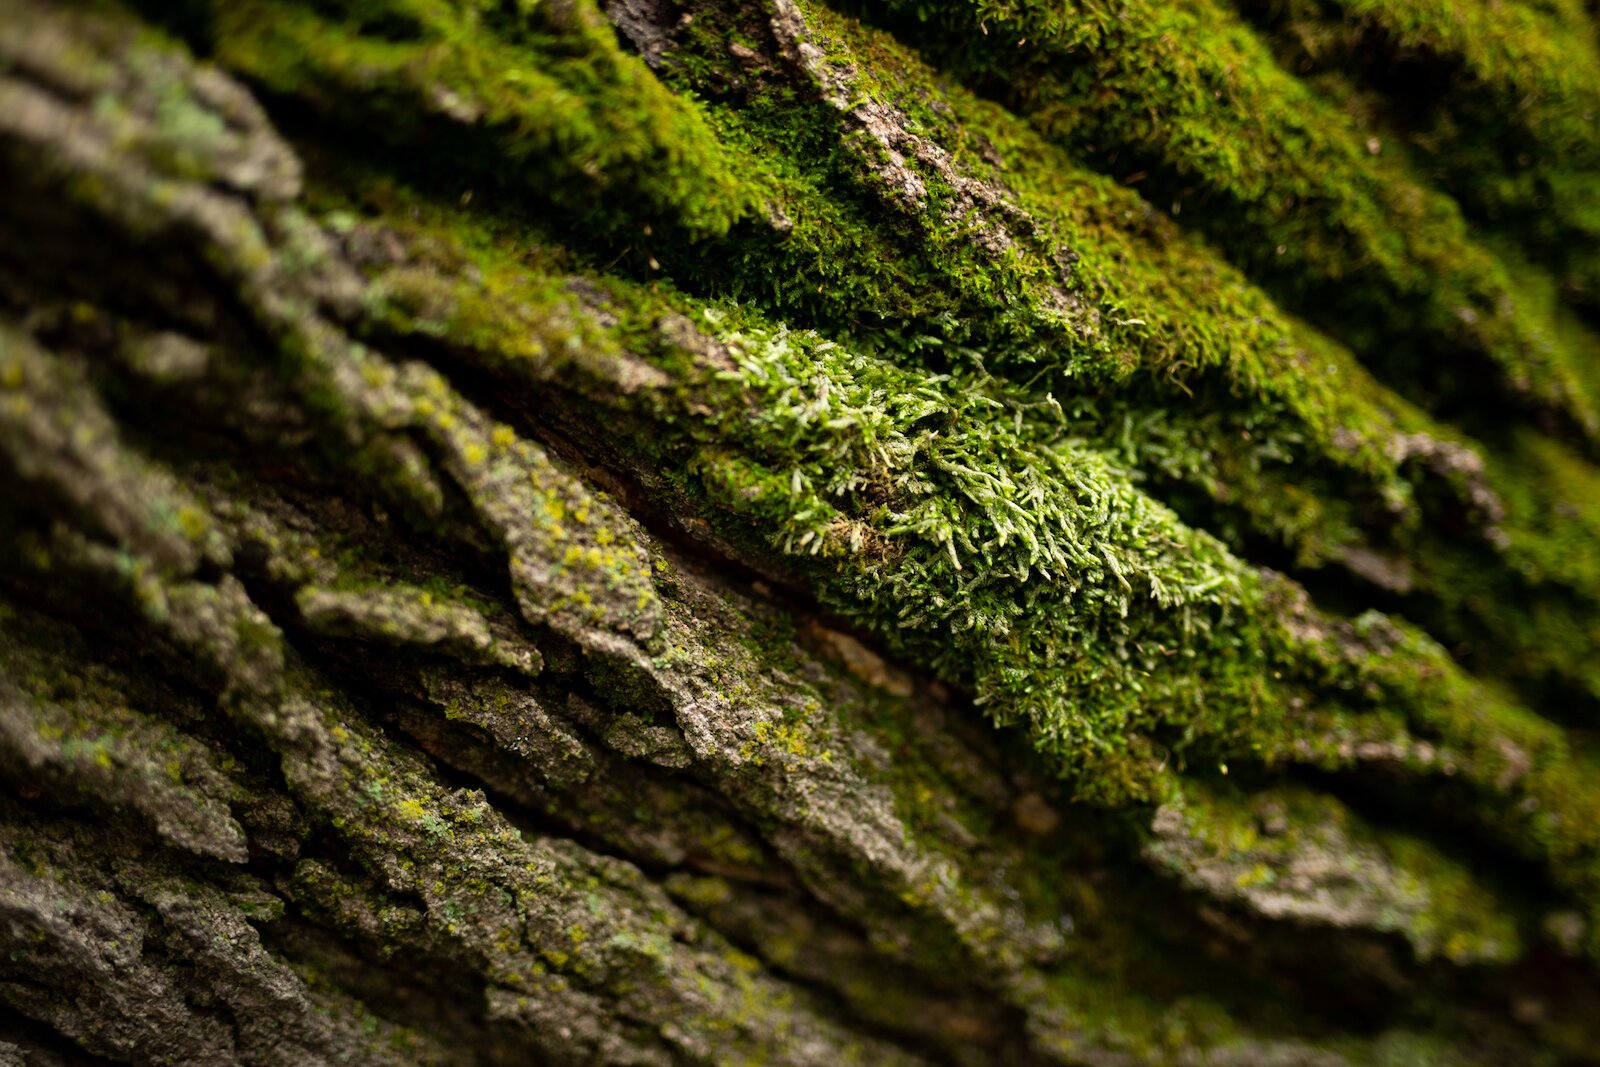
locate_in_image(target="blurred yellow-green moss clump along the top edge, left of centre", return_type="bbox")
[198,0,760,235]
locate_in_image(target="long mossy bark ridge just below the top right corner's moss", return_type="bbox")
[857,2,1597,435]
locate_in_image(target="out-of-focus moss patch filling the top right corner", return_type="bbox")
[1242,0,1600,309]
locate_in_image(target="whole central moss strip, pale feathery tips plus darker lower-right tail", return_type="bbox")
[294,135,1587,959]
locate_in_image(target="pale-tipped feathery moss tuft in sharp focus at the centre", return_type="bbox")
[693,308,1240,767]
